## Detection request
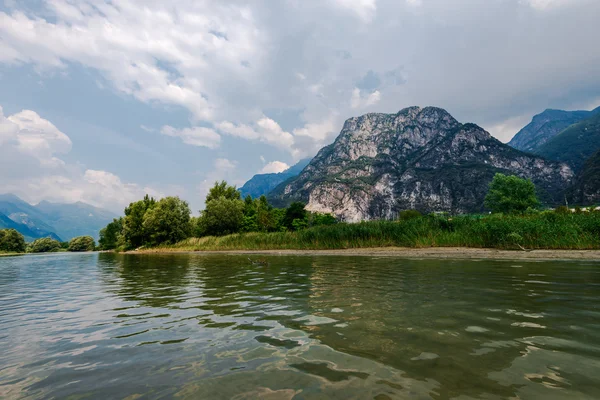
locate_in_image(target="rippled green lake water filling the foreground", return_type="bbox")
[0,253,600,400]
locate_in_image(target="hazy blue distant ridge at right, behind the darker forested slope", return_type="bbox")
[508,107,600,154]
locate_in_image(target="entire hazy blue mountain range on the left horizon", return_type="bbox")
[0,194,116,241]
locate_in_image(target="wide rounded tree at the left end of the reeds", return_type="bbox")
[143,197,192,246]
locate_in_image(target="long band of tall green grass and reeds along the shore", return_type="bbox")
[156,212,600,251]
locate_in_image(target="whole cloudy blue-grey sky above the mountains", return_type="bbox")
[0,0,600,213]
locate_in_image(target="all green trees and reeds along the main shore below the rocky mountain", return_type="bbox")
[89,174,600,258]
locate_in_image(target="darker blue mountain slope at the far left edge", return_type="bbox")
[0,194,61,240]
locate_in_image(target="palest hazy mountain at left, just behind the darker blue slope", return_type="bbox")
[35,201,117,240]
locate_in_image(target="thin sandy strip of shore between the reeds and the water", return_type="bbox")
[128,247,600,262]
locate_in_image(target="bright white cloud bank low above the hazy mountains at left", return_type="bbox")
[0,107,161,212]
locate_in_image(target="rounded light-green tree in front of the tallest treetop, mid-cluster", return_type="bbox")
[199,196,244,236]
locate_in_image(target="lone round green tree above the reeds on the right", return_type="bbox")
[484,174,540,213]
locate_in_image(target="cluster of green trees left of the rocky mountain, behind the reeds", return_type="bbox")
[98,181,337,250]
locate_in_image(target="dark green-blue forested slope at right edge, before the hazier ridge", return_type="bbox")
[536,113,600,171]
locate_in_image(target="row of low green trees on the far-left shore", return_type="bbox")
[0,229,96,253]
